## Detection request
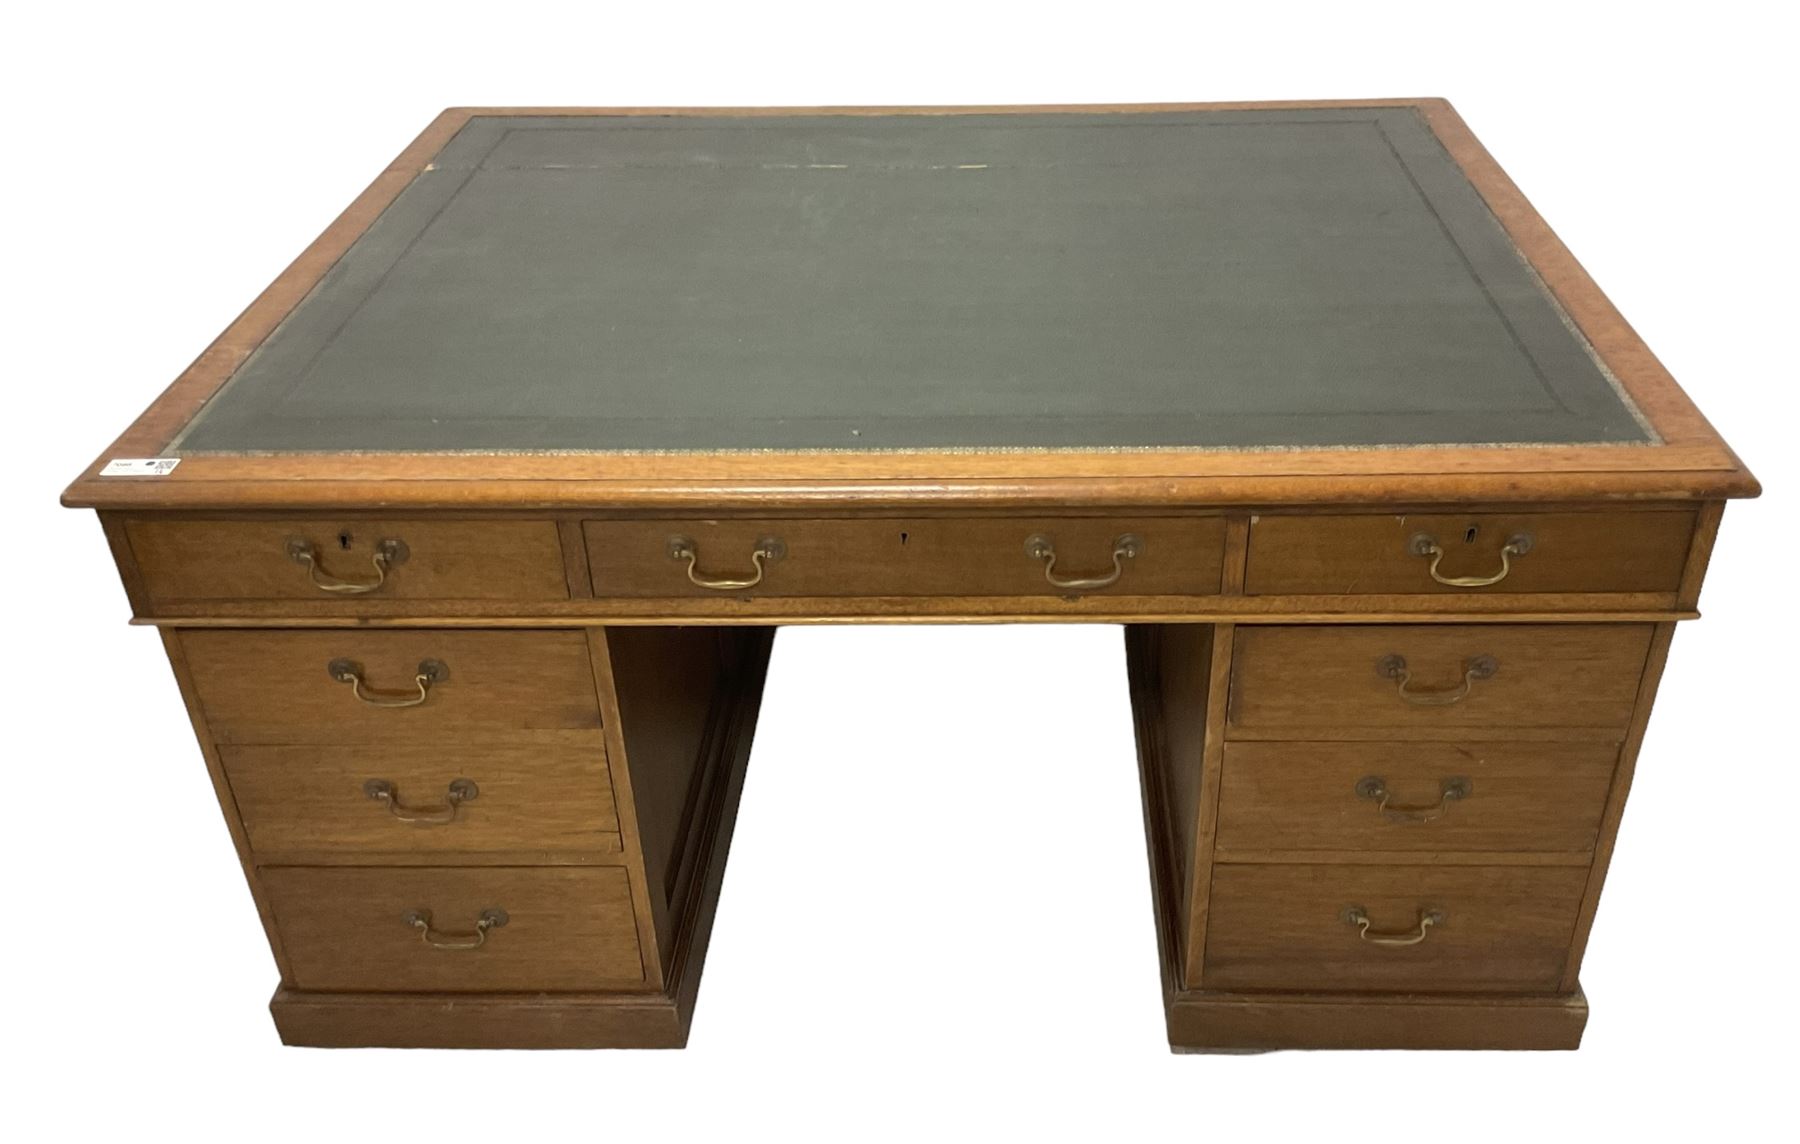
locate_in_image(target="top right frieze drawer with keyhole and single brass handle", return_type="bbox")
[1244,511,1694,595]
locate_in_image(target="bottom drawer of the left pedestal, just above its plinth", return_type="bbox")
[261,865,644,993]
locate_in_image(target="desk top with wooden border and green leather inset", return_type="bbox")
[65,101,1755,507]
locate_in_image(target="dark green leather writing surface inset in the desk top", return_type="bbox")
[176,108,1649,453]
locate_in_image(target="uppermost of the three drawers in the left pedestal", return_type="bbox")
[182,630,599,745]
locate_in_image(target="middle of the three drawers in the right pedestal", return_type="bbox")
[1219,741,1618,853]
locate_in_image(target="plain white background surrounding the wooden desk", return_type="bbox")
[0,0,1800,1140]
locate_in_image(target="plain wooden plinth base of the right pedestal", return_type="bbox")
[1166,991,1588,1052]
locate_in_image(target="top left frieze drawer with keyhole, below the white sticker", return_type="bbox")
[126,518,569,603]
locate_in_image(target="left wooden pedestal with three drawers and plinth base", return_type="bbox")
[164,611,774,1049]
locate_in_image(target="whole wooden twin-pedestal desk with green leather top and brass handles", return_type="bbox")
[65,101,1759,1049]
